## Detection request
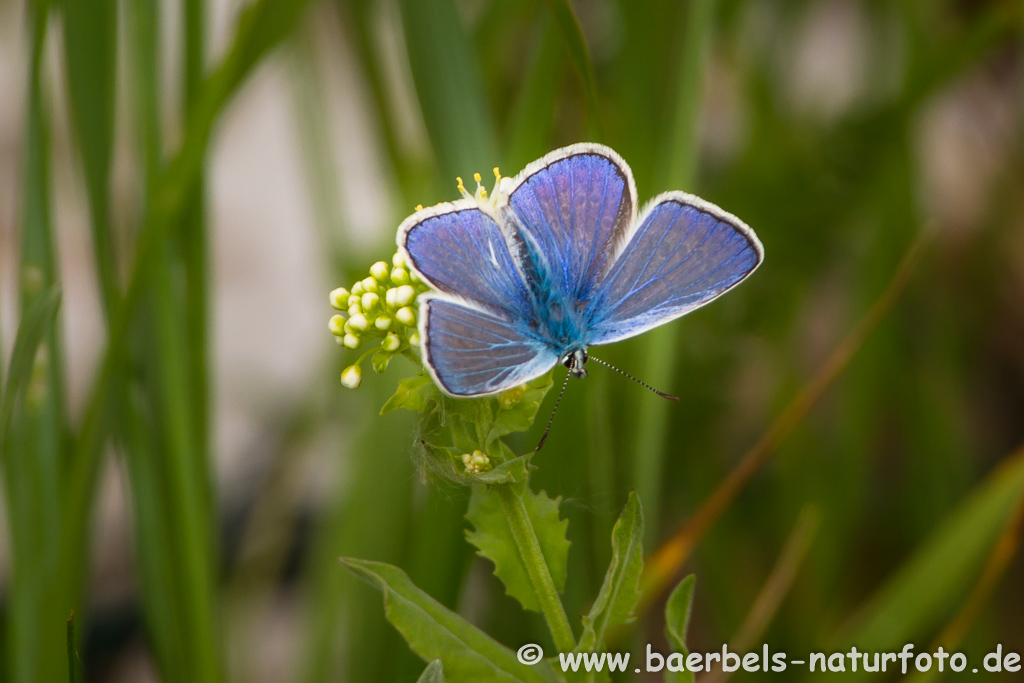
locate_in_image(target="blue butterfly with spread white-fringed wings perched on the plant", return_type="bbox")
[397,143,764,396]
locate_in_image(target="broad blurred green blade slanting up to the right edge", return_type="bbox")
[836,453,1024,678]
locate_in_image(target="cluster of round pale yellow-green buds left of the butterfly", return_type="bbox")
[328,253,429,389]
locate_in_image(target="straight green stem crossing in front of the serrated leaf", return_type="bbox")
[495,485,575,652]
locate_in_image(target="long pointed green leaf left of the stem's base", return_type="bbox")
[341,557,557,683]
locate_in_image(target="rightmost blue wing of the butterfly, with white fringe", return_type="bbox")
[588,193,764,344]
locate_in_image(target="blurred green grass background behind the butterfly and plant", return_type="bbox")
[0,0,1024,683]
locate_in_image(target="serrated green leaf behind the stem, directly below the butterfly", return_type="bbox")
[466,486,569,612]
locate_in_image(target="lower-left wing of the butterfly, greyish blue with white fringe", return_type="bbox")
[420,295,558,396]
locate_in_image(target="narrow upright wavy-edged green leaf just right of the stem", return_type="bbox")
[577,492,643,651]
